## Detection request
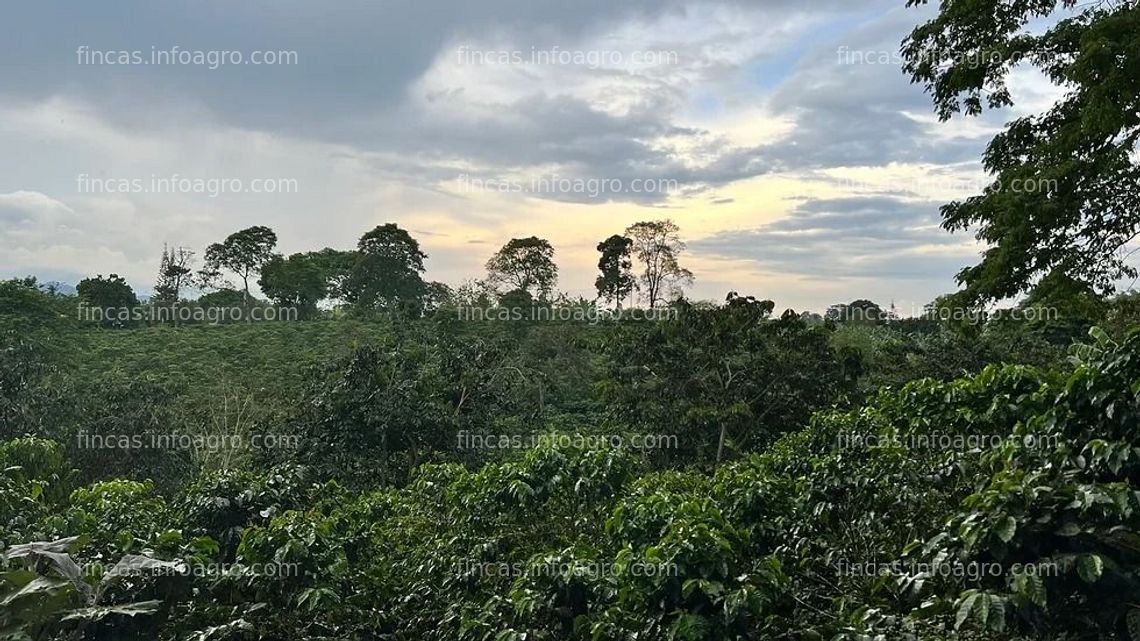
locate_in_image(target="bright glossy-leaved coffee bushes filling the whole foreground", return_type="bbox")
[0,328,1140,641]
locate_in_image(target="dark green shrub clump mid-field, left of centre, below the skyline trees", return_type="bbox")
[299,323,539,485]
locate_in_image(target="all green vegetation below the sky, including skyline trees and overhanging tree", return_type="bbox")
[0,0,1140,641]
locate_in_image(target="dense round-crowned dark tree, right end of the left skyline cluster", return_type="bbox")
[344,222,428,309]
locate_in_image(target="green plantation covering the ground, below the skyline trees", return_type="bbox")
[0,271,1140,640]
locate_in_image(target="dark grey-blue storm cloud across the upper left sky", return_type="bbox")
[0,0,857,135]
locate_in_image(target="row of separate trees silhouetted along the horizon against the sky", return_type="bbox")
[76,220,692,326]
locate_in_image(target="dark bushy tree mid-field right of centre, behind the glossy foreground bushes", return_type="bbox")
[603,293,842,461]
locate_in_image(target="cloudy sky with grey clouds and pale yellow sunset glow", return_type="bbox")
[0,0,1055,311]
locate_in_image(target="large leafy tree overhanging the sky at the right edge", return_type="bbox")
[903,0,1140,305]
